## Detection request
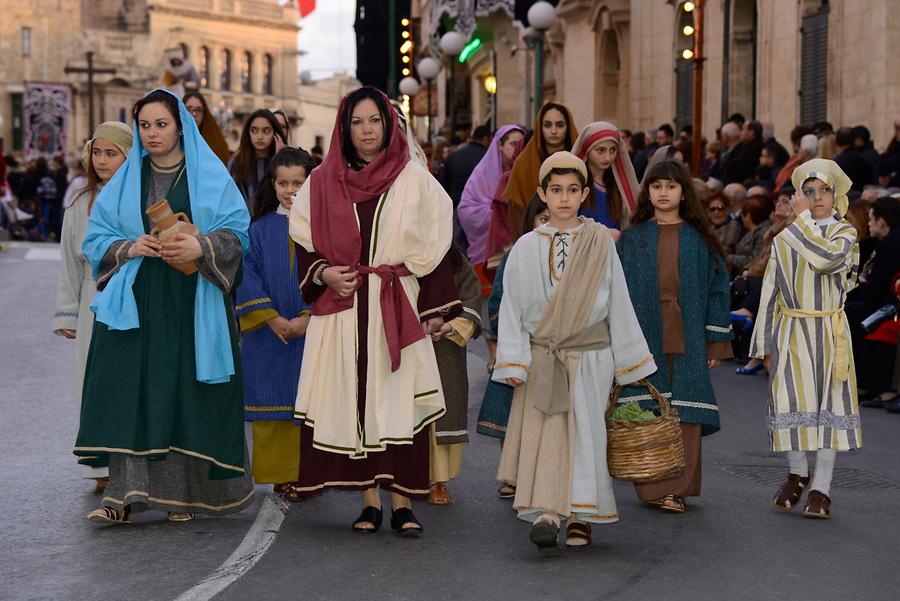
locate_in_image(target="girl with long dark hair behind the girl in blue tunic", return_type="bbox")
[228,109,284,206]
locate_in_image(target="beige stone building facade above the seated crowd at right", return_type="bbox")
[413,0,900,148]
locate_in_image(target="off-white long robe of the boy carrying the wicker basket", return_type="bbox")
[492,225,656,523]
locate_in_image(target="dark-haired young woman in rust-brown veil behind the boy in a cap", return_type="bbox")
[503,101,578,243]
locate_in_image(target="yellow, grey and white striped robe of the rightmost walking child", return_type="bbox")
[750,210,862,451]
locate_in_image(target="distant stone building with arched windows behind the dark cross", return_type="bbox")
[0,0,301,154]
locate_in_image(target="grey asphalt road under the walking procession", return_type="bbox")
[0,244,900,601]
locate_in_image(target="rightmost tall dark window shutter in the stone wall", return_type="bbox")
[800,6,828,125]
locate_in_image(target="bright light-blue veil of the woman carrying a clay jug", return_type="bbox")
[82,90,250,384]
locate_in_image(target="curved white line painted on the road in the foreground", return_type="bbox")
[175,495,288,601]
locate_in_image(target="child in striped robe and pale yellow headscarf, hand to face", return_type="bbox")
[750,159,862,518]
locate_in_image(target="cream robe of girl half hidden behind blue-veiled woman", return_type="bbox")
[53,192,109,478]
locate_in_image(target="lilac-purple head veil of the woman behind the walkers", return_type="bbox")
[456,125,525,265]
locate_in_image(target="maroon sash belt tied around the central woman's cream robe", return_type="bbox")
[357,264,425,372]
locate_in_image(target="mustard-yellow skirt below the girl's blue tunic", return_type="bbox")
[252,420,300,484]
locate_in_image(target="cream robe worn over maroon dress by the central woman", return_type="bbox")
[290,161,453,457]
